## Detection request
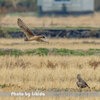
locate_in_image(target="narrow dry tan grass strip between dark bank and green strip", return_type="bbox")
[0,39,100,50]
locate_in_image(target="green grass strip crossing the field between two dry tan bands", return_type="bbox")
[0,48,100,56]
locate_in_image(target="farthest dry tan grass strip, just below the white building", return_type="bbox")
[1,13,100,27]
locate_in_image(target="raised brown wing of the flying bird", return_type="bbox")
[17,18,34,38]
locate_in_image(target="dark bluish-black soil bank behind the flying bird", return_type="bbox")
[0,29,100,38]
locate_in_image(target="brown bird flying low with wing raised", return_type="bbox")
[17,18,48,42]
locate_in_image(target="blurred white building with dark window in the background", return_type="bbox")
[37,0,100,14]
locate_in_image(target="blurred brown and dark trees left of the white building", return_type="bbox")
[0,0,38,13]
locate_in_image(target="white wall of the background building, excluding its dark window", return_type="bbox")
[38,0,94,12]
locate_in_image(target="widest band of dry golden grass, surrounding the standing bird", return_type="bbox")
[0,56,100,91]
